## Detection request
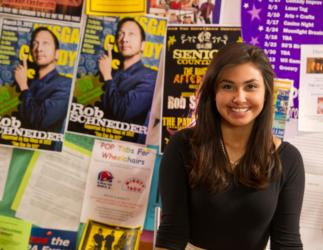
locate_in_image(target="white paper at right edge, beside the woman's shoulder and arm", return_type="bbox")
[287,132,323,250]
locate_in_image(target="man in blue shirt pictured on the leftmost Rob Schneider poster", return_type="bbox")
[15,27,71,133]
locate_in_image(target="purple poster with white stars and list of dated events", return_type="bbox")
[241,0,323,118]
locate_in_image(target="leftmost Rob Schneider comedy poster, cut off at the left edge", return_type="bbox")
[0,18,79,151]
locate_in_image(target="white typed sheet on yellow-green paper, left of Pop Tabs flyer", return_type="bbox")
[12,141,90,231]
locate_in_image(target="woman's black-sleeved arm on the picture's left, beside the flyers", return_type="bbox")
[156,132,190,250]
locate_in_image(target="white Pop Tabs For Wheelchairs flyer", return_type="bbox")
[81,140,156,227]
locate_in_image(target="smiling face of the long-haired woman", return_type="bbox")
[215,63,265,128]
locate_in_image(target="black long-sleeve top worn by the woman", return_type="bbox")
[156,130,305,250]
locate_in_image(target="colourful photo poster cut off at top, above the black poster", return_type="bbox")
[149,0,221,25]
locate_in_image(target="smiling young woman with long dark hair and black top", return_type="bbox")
[156,44,304,250]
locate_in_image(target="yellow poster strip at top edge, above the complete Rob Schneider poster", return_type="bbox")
[86,0,146,16]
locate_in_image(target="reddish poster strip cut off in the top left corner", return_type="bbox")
[0,0,83,22]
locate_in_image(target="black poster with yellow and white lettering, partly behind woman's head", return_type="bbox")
[161,26,241,152]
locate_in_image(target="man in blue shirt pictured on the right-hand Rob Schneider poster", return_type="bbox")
[99,17,157,137]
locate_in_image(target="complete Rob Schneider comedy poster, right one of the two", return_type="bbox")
[68,16,166,144]
